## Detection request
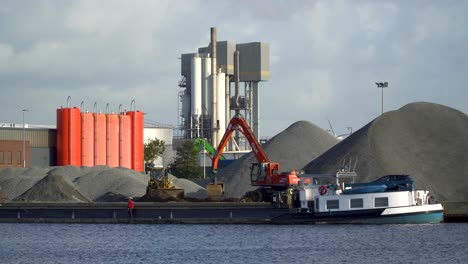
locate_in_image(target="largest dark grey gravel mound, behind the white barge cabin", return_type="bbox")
[305,103,468,201]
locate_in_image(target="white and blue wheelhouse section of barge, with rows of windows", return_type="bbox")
[273,172,443,224]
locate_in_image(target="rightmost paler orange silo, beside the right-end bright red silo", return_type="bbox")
[119,113,132,169]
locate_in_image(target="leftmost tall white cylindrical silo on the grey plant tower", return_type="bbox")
[190,54,202,135]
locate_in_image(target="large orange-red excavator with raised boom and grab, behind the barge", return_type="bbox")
[207,115,300,201]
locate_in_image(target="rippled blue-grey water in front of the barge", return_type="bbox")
[0,224,468,264]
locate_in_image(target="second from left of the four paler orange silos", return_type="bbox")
[93,113,106,166]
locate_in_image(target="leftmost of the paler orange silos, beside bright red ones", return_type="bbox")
[81,112,94,167]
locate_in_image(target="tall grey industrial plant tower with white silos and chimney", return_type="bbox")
[178,28,270,150]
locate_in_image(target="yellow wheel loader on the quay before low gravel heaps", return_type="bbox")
[144,167,184,202]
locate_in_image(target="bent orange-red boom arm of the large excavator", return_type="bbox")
[212,115,270,174]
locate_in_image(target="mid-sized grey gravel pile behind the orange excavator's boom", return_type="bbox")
[217,121,338,198]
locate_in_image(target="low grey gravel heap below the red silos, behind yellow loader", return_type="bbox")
[0,166,206,202]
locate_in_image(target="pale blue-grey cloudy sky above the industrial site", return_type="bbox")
[0,0,468,138]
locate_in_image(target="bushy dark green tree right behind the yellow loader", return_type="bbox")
[171,141,201,178]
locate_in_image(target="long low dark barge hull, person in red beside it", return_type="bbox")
[0,202,289,224]
